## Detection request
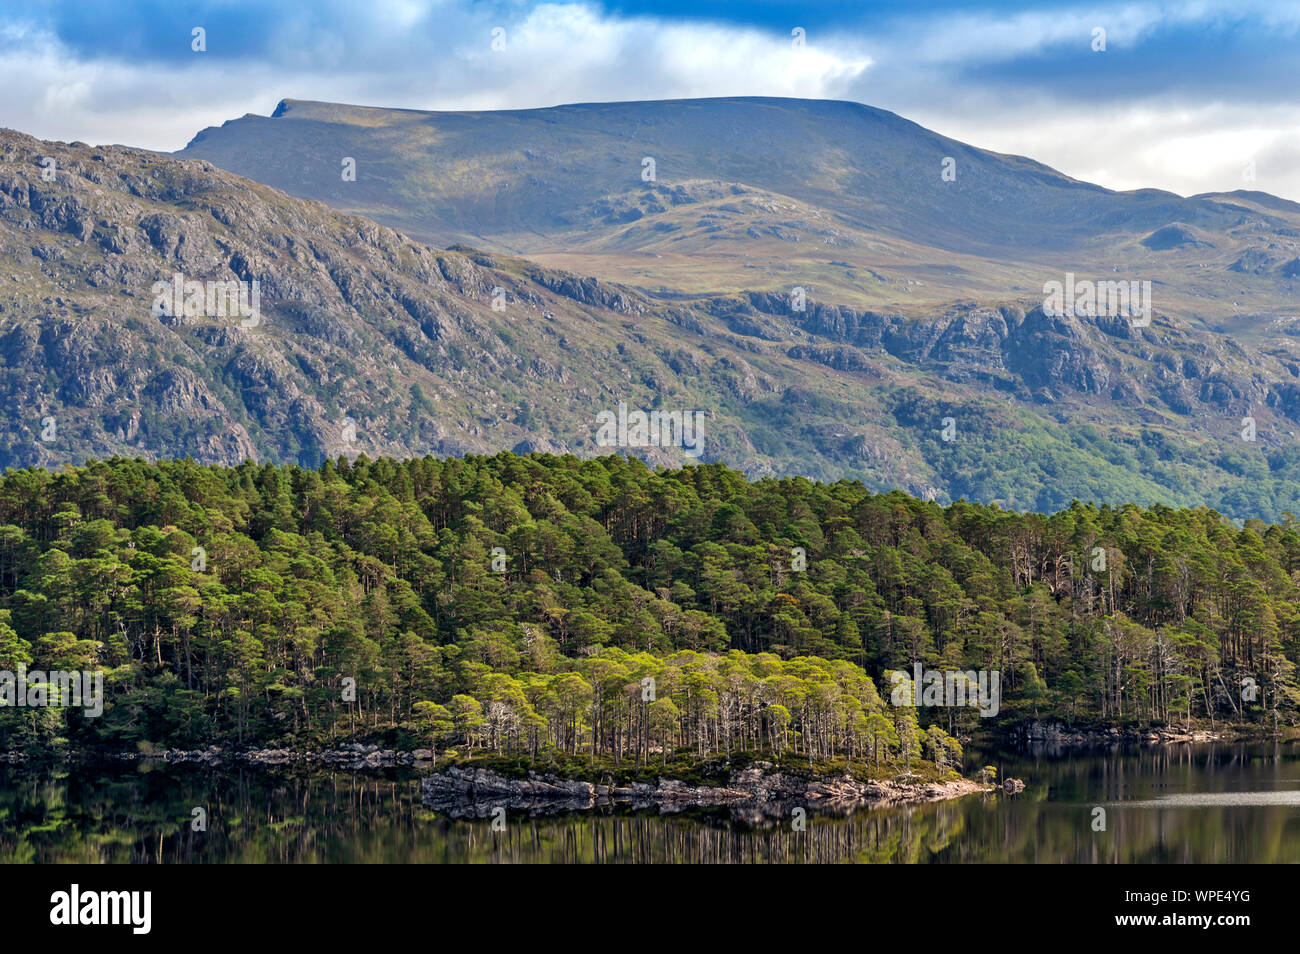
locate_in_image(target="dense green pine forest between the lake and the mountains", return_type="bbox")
[0,454,1300,768]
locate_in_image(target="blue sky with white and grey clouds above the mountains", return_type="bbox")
[0,0,1300,200]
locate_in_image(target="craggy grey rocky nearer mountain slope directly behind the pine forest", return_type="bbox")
[0,110,1300,519]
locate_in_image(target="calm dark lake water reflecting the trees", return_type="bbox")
[0,743,1300,863]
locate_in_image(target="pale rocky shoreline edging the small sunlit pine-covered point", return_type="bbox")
[421,763,988,821]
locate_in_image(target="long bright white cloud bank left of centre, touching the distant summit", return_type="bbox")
[0,4,871,151]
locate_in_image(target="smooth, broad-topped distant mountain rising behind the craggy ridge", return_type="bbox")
[177,97,1300,327]
